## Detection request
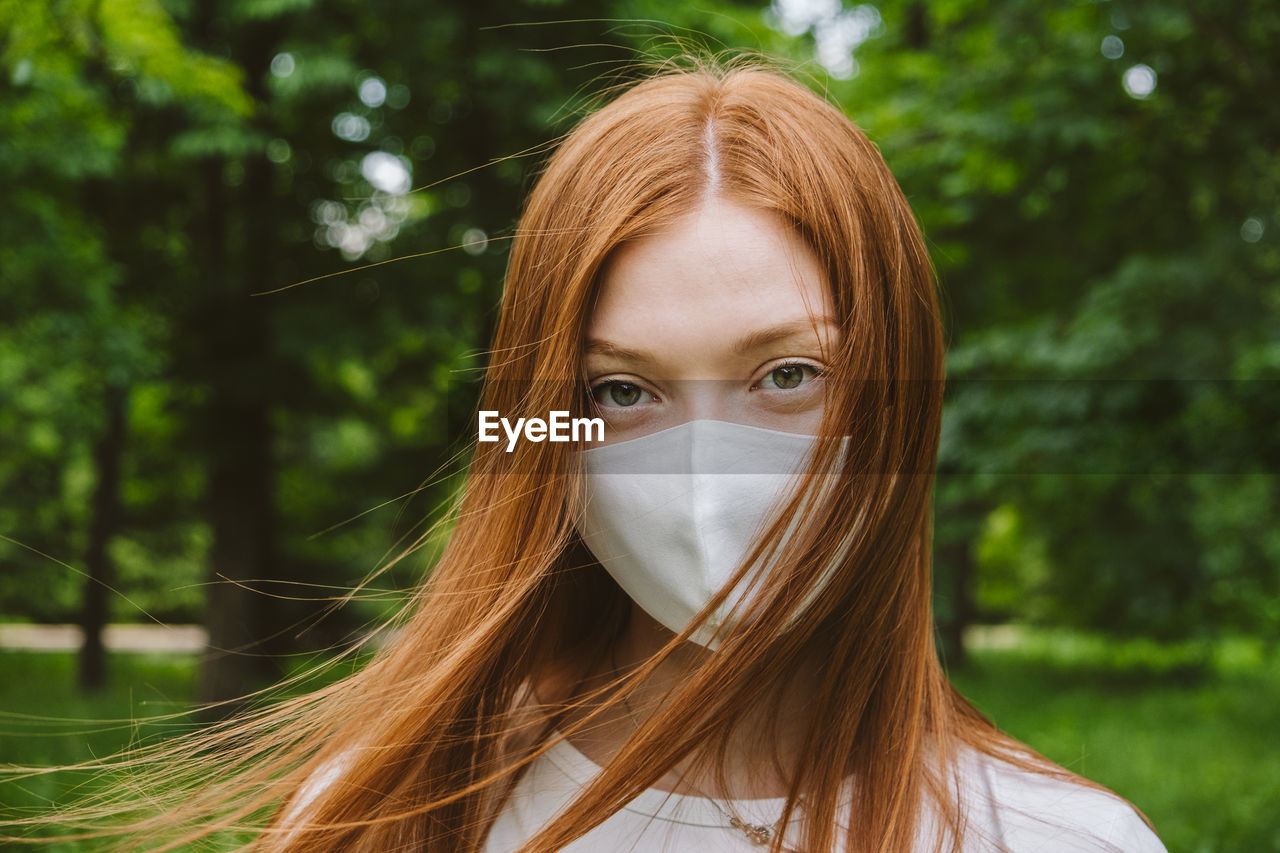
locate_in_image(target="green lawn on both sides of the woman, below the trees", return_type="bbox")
[0,631,1280,853]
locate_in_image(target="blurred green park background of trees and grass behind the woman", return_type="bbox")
[0,0,1280,852]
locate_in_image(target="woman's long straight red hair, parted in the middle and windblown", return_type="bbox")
[2,51,1152,853]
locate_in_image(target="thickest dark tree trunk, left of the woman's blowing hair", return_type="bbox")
[192,0,288,717]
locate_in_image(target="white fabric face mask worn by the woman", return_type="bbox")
[577,420,844,648]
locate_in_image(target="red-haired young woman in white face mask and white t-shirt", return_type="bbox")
[7,56,1164,853]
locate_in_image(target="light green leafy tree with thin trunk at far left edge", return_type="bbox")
[0,4,244,686]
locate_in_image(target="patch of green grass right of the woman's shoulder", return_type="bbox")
[952,631,1280,853]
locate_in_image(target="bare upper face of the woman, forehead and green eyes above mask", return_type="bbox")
[584,199,838,443]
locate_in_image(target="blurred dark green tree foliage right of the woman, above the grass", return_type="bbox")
[835,0,1280,637]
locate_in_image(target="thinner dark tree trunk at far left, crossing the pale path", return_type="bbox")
[78,384,128,693]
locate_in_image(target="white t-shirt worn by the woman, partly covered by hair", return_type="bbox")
[484,738,1167,853]
